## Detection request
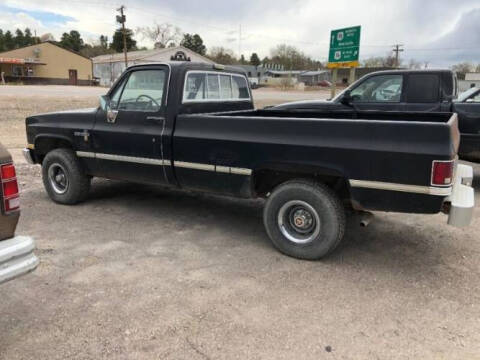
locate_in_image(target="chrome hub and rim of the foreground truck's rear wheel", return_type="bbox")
[277,200,320,244]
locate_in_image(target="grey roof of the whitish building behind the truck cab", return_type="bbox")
[92,46,214,64]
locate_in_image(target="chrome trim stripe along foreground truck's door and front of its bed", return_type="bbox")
[77,151,252,176]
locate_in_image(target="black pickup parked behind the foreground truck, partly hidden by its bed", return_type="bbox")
[275,70,480,162]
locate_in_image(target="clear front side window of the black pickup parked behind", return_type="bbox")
[350,75,403,102]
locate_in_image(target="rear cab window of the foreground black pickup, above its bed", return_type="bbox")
[183,71,250,103]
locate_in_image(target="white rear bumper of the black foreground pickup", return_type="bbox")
[446,164,475,227]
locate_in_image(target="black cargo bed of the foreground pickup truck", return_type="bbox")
[173,110,459,213]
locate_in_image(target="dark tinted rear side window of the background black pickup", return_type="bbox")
[407,74,440,103]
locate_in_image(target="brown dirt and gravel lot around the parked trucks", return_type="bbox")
[0,87,480,360]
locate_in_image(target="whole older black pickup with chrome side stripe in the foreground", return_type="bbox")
[24,62,474,259]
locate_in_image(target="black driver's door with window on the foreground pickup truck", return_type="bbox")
[92,65,169,183]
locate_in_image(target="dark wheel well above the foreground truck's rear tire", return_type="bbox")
[253,170,350,199]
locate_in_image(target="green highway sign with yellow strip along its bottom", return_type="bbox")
[328,26,361,68]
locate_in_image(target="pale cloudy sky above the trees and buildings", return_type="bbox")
[0,0,480,67]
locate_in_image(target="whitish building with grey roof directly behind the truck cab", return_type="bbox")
[92,46,214,86]
